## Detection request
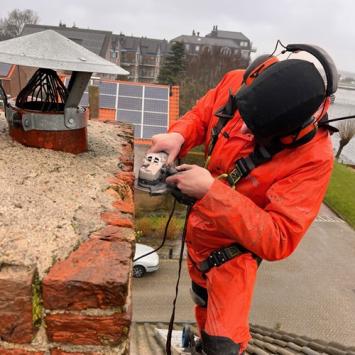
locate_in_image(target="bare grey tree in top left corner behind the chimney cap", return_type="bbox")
[0,9,39,40]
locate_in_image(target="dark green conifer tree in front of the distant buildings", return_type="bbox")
[158,42,186,85]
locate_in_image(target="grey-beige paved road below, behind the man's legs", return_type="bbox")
[133,206,355,346]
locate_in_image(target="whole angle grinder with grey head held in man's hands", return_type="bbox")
[136,152,196,205]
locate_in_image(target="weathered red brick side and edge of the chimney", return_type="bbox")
[0,122,134,355]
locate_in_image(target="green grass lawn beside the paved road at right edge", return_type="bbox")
[325,162,355,228]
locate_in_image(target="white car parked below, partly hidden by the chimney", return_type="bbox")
[133,243,159,277]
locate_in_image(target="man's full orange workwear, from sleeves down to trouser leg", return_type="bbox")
[169,70,333,352]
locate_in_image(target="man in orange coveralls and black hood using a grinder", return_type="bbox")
[151,51,333,355]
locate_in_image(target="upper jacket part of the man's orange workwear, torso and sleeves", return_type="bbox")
[170,70,333,262]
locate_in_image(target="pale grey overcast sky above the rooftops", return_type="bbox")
[0,0,355,72]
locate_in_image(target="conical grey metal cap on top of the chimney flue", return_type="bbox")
[0,30,129,75]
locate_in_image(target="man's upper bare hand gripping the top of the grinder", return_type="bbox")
[149,132,185,164]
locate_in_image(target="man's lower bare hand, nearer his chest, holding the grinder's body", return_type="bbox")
[166,164,214,199]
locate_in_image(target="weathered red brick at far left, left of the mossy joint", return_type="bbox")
[0,265,35,344]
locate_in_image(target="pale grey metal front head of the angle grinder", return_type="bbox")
[136,152,168,195]
